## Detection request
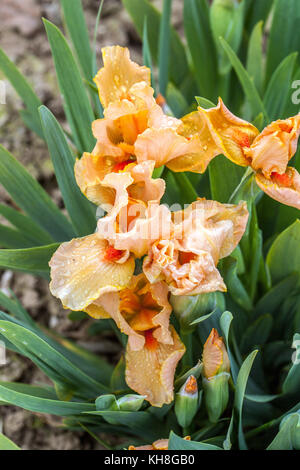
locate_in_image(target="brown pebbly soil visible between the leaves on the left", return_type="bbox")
[0,0,182,450]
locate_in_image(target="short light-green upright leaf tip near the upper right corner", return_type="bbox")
[247,21,264,93]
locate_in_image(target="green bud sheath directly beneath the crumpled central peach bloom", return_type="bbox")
[170,292,225,333]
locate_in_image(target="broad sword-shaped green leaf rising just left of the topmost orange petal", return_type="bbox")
[43,19,95,153]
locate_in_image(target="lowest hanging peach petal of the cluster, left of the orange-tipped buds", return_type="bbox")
[126,327,185,407]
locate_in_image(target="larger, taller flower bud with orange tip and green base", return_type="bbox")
[202,328,230,423]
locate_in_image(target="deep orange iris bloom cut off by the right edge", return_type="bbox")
[198,98,300,209]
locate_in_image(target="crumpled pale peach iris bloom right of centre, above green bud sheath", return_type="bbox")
[143,199,248,295]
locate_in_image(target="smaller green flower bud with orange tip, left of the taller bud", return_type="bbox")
[175,375,198,428]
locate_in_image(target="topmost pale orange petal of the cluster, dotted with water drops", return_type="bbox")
[94,46,150,108]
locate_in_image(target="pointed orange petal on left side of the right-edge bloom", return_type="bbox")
[198,98,259,166]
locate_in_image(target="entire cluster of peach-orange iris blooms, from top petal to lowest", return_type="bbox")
[50,46,300,406]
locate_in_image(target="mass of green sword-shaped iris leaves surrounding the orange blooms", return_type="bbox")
[0,0,300,451]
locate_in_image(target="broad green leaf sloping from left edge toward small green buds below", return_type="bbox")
[0,320,108,398]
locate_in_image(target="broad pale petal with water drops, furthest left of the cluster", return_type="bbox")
[49,233,135,310]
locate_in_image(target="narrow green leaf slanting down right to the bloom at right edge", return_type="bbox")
[219,37,269,120]
